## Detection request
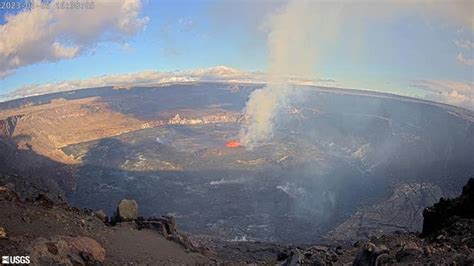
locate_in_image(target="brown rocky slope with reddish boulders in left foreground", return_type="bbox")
[0,187,216,265]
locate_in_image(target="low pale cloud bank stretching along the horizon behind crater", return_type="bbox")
[0,66,474,112]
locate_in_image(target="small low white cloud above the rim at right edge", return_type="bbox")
[412,80,474,110]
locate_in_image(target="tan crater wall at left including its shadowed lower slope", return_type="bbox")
[0,94,238,196]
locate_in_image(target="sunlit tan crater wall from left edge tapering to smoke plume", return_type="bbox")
[0,97,239,164]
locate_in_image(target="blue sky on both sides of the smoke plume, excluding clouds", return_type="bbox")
[0,0,474,108]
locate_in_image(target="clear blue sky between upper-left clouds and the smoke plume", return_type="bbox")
[0,0,265,89]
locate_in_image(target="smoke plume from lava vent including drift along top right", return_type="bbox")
[240,0,474,150]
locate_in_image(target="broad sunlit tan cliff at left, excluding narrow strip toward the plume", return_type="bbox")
[0,98,148,164]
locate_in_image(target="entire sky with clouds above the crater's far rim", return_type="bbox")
[0,0,474,110]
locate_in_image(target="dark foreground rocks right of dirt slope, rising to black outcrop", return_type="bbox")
[216,179,474,266]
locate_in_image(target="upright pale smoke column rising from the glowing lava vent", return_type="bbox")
[240,1,332,149]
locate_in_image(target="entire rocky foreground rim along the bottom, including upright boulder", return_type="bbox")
[0,179,474,265]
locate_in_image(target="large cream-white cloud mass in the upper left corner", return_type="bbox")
[0,0,148,76]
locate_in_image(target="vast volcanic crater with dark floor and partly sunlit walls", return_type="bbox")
[0,83,474,243]
